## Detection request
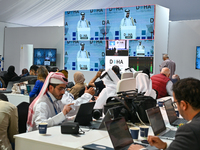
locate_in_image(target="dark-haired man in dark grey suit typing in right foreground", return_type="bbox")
[129,78,200,150]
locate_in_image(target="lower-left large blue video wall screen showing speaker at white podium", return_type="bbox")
[65,41,105,71]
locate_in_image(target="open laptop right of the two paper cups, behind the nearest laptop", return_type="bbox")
[146,106,176,140]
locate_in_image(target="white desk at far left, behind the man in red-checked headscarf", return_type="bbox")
[4,93,29,106]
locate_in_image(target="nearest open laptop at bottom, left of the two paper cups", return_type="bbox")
[105,117,158,150]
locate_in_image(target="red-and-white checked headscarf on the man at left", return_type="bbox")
[27,72,67,131]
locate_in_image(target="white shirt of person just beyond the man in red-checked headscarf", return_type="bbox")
[61,91,92,117]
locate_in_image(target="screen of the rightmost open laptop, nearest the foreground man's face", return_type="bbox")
[164,99,177,124]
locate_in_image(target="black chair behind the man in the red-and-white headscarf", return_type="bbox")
[17,102,30,133]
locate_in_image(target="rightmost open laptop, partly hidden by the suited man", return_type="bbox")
[164,98,187,126]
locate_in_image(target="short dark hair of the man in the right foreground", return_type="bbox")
[173,78,200,110]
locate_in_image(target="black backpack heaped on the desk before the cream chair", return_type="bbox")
[104,91,157,123]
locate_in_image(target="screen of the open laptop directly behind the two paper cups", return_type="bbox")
[146,107,166,135]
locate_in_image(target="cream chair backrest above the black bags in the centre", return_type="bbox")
[117,78,136,92]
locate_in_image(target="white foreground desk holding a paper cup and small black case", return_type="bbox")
[14,126,108,150]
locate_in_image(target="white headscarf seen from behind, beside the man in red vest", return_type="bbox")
[136,73,156,99]
